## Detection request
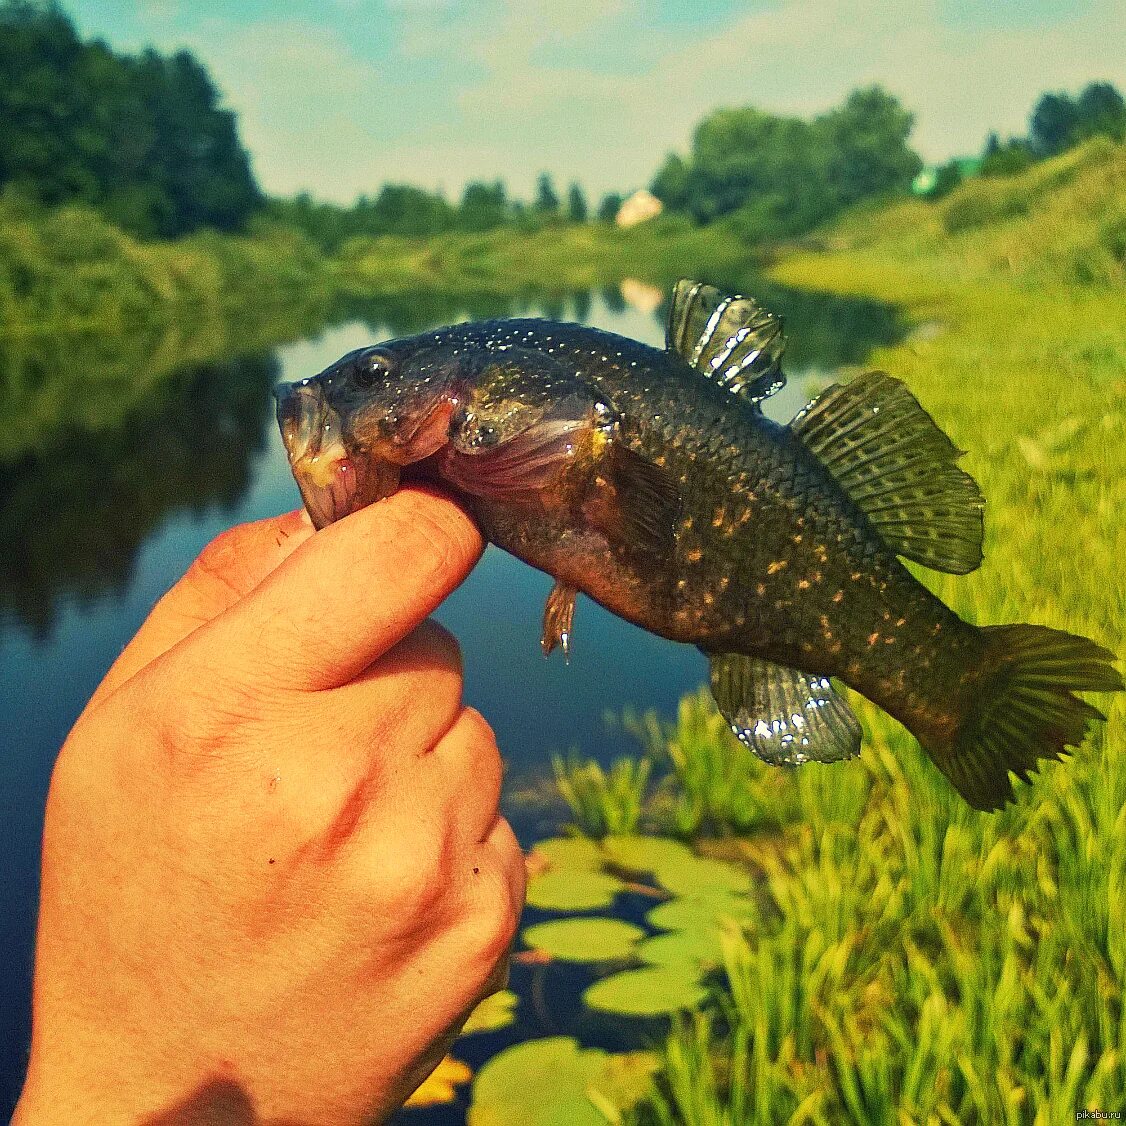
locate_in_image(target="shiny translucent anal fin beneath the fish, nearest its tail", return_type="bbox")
[711,653,860,766]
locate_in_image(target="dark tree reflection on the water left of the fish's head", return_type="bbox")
[0,351,277,637]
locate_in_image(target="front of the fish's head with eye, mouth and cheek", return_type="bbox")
[274,340,462,528]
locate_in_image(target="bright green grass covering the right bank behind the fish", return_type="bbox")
[540,143,1126,1126]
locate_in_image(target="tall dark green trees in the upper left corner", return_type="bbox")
[0,0,261,238]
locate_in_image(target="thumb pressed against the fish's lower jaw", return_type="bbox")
[193,489,483,690]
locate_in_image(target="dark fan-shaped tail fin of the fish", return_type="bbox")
[919,625,1124,810]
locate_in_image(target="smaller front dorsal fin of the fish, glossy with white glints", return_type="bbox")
[665,280,786,405]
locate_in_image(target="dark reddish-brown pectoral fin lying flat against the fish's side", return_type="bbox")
[583,436,681,561]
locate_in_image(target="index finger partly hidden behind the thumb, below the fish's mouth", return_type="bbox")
[88,509,313,706]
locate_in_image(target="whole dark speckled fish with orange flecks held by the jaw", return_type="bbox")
[276,279,1124,810]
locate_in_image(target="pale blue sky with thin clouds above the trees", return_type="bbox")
[62,0,1126,203]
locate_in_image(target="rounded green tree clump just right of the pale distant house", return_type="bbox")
[652,87,922,242]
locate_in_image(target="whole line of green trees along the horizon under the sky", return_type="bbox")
[0,0,1126,251]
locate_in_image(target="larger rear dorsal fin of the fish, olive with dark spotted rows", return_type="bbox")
[789,372,985,574]
